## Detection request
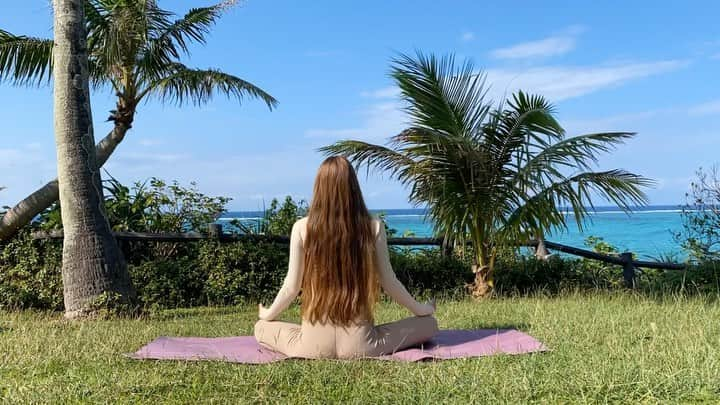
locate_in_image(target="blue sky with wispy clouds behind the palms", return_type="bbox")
[0,0,720,210]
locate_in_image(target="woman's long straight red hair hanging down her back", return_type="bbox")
[301,156,378,325]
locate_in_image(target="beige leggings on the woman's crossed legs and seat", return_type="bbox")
[255,316,438,359]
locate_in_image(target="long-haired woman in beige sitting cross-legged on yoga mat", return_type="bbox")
[255,157,437,359]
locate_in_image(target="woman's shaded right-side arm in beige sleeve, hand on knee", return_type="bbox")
[375,221,435,316]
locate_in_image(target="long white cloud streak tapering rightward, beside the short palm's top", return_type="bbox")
[486,60,689,102]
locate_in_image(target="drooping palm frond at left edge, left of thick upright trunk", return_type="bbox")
[0,30,53,85]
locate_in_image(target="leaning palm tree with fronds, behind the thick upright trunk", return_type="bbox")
[0,0,277,240]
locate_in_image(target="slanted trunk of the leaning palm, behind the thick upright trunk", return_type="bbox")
[0,122,130,241]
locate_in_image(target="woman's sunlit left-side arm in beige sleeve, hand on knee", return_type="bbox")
[259,220,306,321]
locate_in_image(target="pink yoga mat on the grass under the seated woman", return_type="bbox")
[129,329,547,364]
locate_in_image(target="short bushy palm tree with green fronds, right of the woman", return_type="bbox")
[321,53,652,296]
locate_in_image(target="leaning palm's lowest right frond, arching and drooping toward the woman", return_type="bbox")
[138,63,277,109]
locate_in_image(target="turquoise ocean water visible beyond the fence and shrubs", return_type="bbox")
[218,206,684,259]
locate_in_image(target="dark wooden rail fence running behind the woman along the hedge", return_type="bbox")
[33,224,687,288]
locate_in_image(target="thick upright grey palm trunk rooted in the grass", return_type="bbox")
[53,0,135,318]
